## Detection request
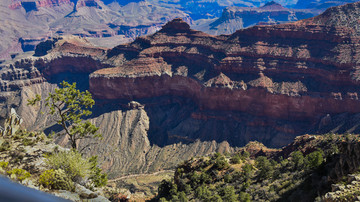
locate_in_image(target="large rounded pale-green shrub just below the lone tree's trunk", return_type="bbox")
[45,150,92,181]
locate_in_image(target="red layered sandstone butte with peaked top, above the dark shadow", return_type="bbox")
[89,3,360,123]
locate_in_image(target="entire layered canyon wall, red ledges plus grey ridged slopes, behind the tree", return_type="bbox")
[0,3,360,177]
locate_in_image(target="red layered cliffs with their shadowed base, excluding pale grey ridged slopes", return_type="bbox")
[1,3,360,150]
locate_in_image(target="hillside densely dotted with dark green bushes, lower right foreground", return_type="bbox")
[156,135,358,201]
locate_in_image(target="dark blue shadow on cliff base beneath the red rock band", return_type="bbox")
[86,96,310,147]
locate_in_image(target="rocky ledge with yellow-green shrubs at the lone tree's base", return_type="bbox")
[0,96,107,198]
